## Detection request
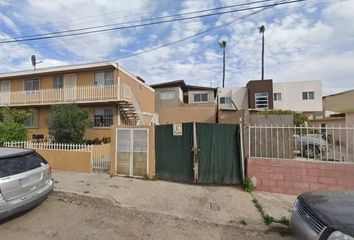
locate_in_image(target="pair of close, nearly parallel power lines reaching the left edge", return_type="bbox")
[0,0,306,43]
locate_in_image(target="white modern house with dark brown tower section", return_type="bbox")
[218,79,322,115]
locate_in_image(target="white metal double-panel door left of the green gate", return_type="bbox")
[116,128,149,176]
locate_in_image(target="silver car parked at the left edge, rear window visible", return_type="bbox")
[0,148,53,220]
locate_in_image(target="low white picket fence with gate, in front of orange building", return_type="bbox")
[4,141,111,170]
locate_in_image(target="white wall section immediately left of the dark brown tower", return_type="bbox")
[218,87,248,110]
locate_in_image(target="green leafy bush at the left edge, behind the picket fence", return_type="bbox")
[0,108,32,146]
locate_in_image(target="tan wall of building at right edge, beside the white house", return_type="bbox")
[323,91,354,112]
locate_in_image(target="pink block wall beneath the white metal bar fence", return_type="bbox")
[247,158,354,195]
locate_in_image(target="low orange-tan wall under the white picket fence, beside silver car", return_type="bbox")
[36,149,92,173]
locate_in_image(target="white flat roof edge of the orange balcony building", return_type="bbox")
[0,62,118,78]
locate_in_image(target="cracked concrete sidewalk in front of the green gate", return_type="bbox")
[53,171,296,231]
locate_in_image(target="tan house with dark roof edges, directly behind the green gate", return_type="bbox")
[151,80,217,124]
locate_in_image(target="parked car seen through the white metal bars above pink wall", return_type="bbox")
[294,134,328,158]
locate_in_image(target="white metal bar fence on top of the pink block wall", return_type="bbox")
[248,125,354,162]
